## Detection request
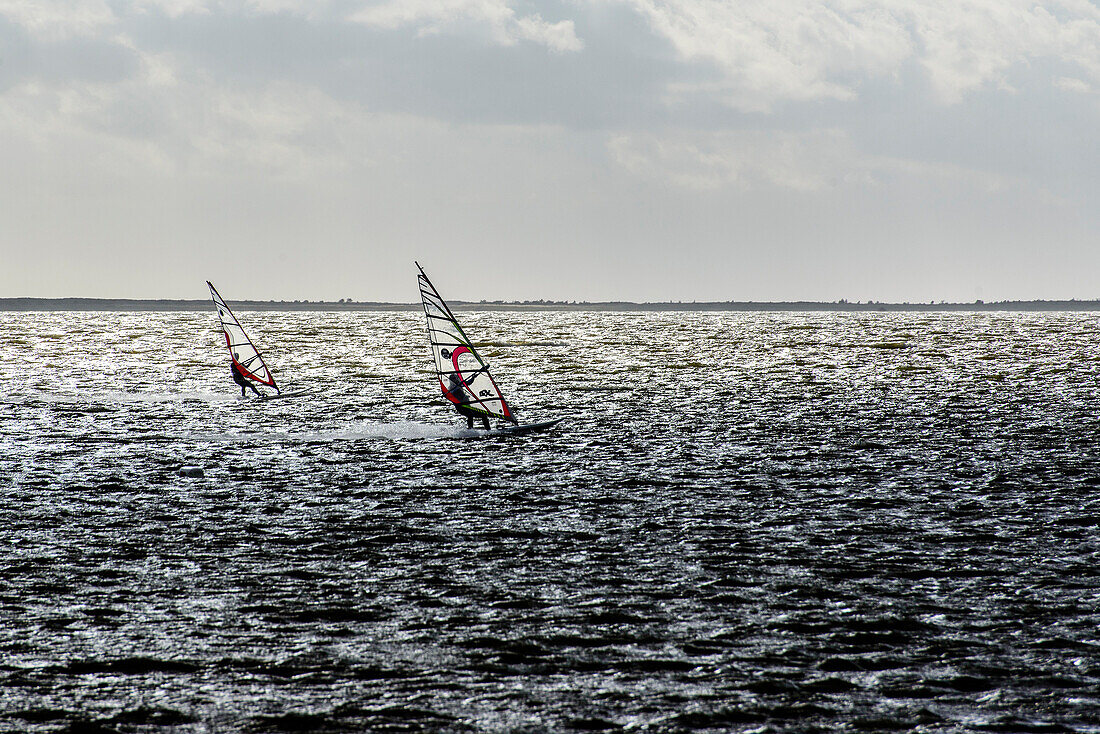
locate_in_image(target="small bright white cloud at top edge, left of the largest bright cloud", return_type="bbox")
[350,0,584,53]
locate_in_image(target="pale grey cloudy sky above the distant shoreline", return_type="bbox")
[0,0,1100,303]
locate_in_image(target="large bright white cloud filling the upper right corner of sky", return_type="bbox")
[618,0,1100,112]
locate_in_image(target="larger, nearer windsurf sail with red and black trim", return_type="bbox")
[416,263,519,425]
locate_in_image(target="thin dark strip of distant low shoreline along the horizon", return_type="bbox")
[0,298,1100,311]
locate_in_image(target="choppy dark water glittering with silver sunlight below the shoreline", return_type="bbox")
[0,313,1100,732]
